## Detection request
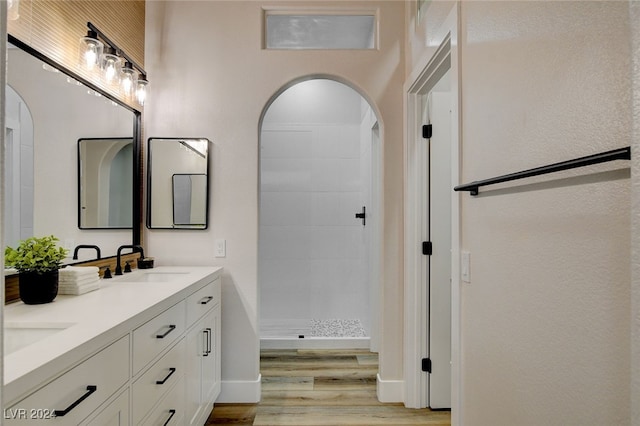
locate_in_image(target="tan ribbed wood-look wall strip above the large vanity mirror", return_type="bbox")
[8,0,145,110]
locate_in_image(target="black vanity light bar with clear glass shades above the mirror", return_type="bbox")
[80,22,149,106]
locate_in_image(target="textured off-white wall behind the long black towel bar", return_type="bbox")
[407,1,631,425]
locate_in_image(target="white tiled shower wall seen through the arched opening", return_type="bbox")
[258,80,371,332]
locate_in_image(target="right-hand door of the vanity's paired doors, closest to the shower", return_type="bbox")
[202,305,220,405]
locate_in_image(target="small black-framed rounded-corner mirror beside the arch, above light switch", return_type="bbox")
[147,138,210,229]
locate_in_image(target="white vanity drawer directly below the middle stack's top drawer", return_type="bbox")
[132,339,186,425]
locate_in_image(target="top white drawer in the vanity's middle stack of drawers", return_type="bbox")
[133,300,185,375]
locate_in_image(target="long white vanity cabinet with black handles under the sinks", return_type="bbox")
[3,267,221,426]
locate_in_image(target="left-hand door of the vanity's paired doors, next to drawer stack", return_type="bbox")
[186,317,207,425]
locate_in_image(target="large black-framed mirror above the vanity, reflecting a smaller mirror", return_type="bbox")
[3,36,141,263]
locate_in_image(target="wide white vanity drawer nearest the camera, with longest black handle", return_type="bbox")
[4,335,129,425]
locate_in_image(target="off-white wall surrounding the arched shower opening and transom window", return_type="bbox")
[145,1,404,400]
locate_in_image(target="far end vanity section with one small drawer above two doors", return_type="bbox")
[185,279,221,425]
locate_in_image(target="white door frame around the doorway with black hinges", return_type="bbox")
[404,3,462,425]
